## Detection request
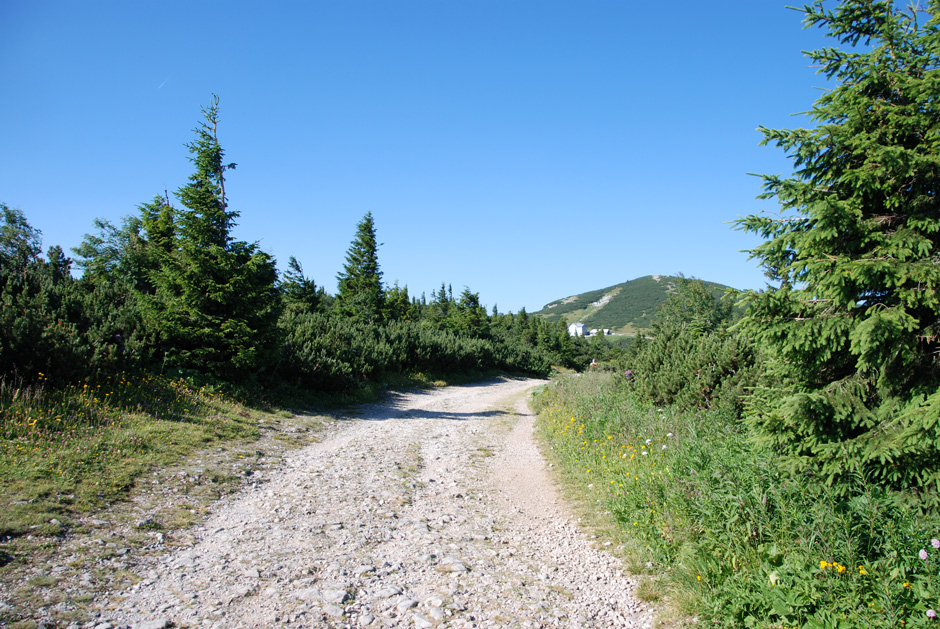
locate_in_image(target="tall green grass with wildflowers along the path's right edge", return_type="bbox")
[536,374,940,628]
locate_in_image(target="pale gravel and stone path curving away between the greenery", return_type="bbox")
[104,379,653,629]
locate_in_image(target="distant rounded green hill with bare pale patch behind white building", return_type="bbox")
[533,275,728,334]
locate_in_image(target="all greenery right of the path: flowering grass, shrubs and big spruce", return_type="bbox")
[536,0,940,629]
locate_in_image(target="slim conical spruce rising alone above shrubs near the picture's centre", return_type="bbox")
[335,212,385,323]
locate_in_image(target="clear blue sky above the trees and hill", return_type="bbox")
[0,0,825,312]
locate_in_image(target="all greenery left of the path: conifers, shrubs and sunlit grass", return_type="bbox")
[0,98,620,539]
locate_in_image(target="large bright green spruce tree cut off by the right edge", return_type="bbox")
[738,0,940,502]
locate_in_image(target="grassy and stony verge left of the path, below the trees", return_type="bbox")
[0,366,489,629]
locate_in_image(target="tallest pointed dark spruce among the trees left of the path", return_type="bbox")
[144,97,279,380]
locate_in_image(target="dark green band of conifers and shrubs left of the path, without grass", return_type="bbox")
[0,97,619,391]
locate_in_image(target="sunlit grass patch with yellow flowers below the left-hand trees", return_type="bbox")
[0,374,257,536]
